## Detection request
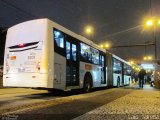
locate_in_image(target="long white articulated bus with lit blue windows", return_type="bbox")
[3,18,132,91]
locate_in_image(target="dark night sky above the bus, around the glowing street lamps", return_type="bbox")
[0,0,160,60]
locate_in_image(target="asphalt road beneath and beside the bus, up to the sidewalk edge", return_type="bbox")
[0,88,133,120]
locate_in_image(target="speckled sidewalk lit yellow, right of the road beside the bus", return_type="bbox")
[74,85,160,120]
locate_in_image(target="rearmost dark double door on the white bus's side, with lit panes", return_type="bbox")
[66,37,79,86]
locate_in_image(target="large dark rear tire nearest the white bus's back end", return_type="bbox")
[83,75,92,92]
